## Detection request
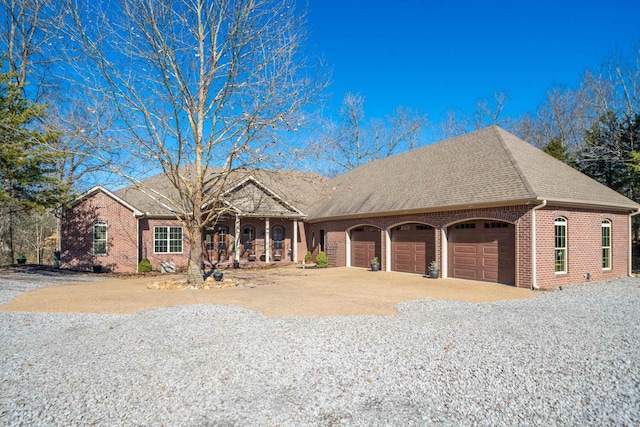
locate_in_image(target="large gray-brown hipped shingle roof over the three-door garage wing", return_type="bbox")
[309,126,640,220]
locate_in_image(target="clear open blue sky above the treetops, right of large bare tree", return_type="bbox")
[308,0,640,124]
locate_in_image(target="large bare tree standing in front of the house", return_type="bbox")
[67,0,325,283]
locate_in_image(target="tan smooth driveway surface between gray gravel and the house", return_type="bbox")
[0,266,536,317]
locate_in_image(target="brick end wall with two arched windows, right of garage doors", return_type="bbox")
[536,207,629,288]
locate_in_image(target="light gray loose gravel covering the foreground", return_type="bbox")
[0,272,640,426]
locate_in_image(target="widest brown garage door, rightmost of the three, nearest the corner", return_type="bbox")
[449,220,515,284]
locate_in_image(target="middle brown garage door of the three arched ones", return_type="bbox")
[391,224,435,274]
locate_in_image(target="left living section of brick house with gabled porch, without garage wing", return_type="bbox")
[60,170,326,272]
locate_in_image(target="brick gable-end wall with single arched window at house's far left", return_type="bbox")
[60,191,138,272]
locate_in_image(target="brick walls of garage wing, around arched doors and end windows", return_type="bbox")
[307,206,629,288]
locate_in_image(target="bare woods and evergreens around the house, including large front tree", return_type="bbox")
[0,0,640,280]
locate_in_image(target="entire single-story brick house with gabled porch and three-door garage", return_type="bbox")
[62,126,640,288]
